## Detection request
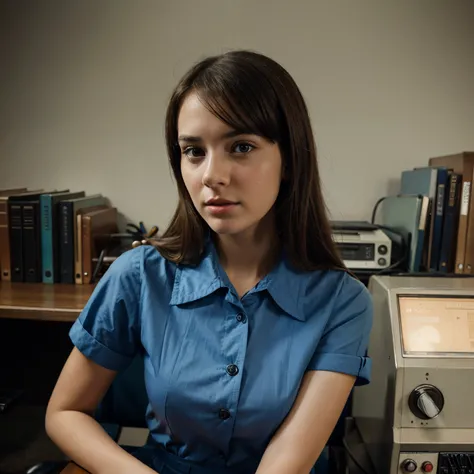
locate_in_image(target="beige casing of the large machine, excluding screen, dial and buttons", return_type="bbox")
[352,276,474,474]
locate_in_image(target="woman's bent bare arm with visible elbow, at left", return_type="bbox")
[46,348,156,474]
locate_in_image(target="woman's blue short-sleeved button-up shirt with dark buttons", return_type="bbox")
[70,242,372,473]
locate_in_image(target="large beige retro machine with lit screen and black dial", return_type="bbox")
[352,276,474,474]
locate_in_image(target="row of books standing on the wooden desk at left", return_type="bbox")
[0,188,118,284]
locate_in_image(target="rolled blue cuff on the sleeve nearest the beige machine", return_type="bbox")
[307,354,372,385]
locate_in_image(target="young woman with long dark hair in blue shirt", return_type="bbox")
[46,51,372,474]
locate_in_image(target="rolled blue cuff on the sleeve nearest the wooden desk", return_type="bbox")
[69,320,133,371]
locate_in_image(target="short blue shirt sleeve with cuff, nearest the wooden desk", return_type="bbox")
[69,248,142,370]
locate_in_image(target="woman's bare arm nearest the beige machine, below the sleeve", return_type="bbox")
[256,370,356,474]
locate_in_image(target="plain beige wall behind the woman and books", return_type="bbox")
[0,0,474,228]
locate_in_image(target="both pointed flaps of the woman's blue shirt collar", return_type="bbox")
[170,239,308,321]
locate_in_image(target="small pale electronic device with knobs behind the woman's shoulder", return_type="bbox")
[332,227,392,270]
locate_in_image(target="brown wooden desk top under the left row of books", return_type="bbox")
[0,281,95,322]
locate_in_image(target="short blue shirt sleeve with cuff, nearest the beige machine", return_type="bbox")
[308,275,373,385]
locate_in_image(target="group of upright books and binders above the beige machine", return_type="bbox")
[377,152,474,274]
